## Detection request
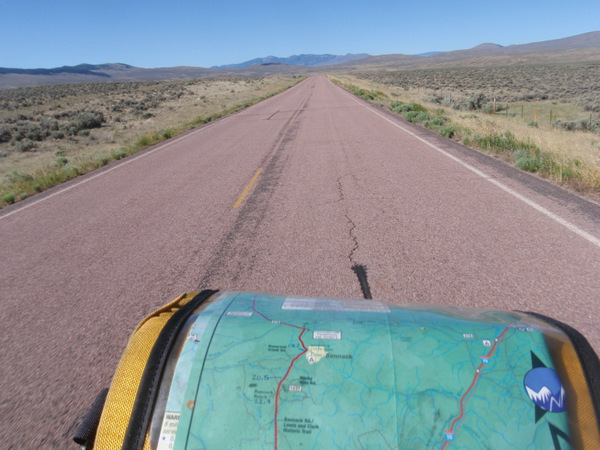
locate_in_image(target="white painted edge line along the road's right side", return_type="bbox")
[344,91,600,248]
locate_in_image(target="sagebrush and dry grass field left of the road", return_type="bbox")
[0,76,303,207]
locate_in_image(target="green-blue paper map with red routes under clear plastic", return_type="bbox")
[154,292,570,450]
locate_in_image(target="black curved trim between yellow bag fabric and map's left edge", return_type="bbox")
[122,289,218,450]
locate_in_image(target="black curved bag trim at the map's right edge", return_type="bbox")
[519,311,600,429]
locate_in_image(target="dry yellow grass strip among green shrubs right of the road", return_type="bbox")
[336,71,600,197]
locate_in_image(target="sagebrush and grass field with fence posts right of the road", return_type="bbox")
[330,64,600,198]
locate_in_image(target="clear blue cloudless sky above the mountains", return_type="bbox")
[0,0,600,68]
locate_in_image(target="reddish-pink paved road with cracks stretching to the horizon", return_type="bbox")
[0,77,600,448]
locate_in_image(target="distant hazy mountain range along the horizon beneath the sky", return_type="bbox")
[0,31,600,89]
